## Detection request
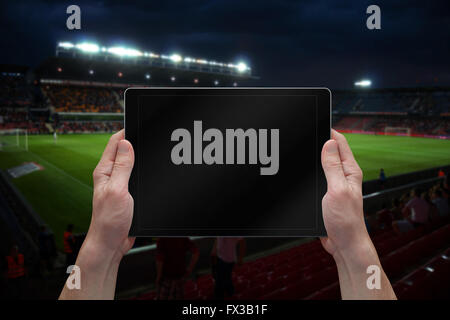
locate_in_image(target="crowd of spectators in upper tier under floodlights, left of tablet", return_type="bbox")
[42,85,123,113]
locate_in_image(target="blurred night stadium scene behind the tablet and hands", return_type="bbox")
[0,0,450,300]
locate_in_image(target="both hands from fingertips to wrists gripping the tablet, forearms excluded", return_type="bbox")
[87,130,369,261]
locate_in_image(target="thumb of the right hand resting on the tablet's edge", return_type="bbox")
[322,140,347,189]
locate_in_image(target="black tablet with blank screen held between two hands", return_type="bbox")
[125,88,331,237]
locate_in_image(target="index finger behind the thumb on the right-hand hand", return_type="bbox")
[331,130,362,189]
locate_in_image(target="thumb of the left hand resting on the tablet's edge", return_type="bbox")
[109,140,134,190]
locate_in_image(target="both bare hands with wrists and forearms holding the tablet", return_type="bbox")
[60,130,396,299]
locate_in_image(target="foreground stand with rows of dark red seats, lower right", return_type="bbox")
[135,178,450,300]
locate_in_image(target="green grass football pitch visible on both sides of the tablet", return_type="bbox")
[0,134,450,246]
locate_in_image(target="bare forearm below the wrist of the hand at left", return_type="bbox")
[59,238,121,300]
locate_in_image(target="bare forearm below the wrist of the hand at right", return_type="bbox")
[333,236,396,300]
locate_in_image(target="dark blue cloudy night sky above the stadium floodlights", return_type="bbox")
[0,0,450,88]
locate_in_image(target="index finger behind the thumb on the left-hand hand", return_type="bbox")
[93,129,124,187]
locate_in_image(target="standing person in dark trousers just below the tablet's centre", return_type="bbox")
[211,238,246,299]
